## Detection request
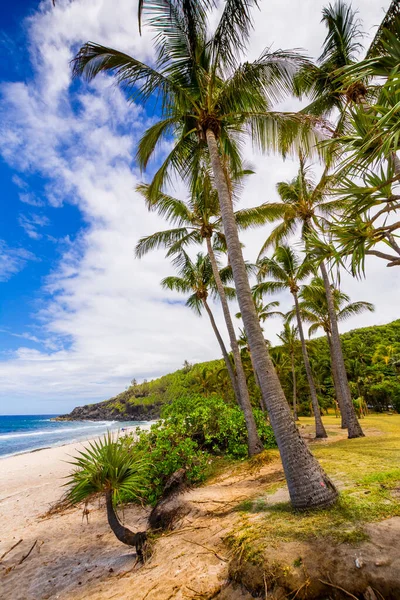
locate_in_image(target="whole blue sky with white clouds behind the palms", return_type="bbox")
[0,0,399,414]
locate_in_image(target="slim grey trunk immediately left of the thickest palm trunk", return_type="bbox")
[206,237,264,456]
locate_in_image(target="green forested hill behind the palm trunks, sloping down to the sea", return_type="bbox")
[60,319,400,420]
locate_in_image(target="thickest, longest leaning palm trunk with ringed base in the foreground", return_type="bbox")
[206,129,338,509]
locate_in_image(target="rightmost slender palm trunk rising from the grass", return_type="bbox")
[320,261,364,438]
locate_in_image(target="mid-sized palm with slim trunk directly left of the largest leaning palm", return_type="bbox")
[136,171,268,420]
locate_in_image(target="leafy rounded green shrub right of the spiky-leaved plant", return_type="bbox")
[122,396,276,504]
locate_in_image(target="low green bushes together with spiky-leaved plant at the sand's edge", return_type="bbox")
[66,395,276,504]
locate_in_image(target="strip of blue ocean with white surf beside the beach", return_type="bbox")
[0,415,144,458]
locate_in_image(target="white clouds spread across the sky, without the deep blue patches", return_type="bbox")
[0,0,398,412]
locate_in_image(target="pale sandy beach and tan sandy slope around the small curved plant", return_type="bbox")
[0,424,250,600]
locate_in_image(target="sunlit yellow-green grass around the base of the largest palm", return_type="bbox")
[228,415,400,560]
